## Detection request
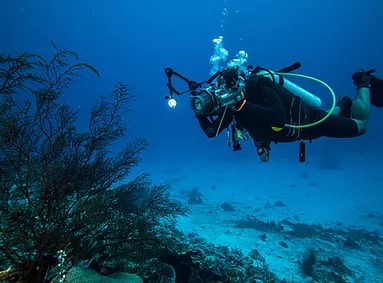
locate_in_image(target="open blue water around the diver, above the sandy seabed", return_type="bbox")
[0,0,383,280]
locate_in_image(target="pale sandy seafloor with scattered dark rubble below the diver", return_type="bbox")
[140,148,383,283]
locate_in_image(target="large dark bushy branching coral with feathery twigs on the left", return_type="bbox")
[0,44,185,282]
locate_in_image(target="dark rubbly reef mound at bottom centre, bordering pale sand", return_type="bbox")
[156,234,278,283]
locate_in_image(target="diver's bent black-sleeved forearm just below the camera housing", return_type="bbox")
[196,111,233,138]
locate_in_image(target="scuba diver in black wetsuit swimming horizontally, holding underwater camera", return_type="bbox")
[165,63,383,162]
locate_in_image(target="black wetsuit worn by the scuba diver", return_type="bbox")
[197,75,359,148]
